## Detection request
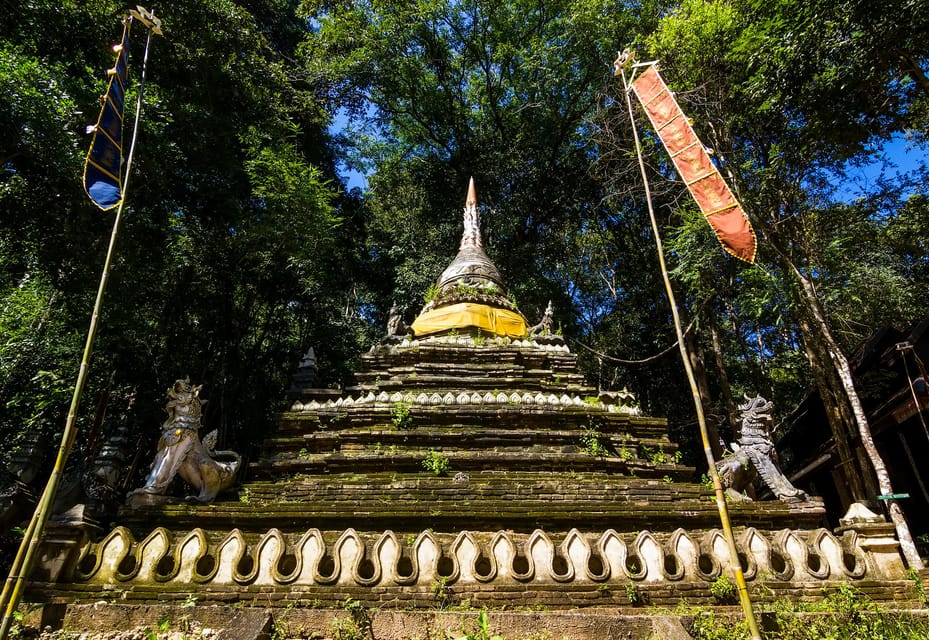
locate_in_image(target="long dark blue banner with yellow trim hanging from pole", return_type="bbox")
[84,19,132,211]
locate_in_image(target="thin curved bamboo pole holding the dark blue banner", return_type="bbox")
[0,18,159,640]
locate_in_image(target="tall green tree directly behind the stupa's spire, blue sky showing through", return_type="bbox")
[303,0,668,329]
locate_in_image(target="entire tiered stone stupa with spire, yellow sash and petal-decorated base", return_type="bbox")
[29,181,911,638]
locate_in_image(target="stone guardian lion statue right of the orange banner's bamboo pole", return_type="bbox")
[716,396,809,502]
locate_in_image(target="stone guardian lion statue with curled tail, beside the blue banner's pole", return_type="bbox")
[129,379,242,502]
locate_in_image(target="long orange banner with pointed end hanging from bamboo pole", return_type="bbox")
[632,65,757,263]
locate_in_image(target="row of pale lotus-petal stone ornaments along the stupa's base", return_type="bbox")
[73,527,888,589]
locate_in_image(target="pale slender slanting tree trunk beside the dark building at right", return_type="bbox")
[782,262,923,569]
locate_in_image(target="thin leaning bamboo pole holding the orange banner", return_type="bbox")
[614,56,761,640]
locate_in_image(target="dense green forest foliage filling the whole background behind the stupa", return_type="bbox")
[0,0,929,490]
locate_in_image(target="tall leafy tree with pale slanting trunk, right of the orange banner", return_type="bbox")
[647,1,924,565]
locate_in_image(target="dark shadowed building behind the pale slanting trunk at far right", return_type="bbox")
[777,320,929,536]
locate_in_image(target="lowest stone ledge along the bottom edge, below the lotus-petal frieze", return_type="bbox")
[23,596,929,640]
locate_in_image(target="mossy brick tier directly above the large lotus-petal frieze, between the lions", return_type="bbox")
[114,472,823,534]
